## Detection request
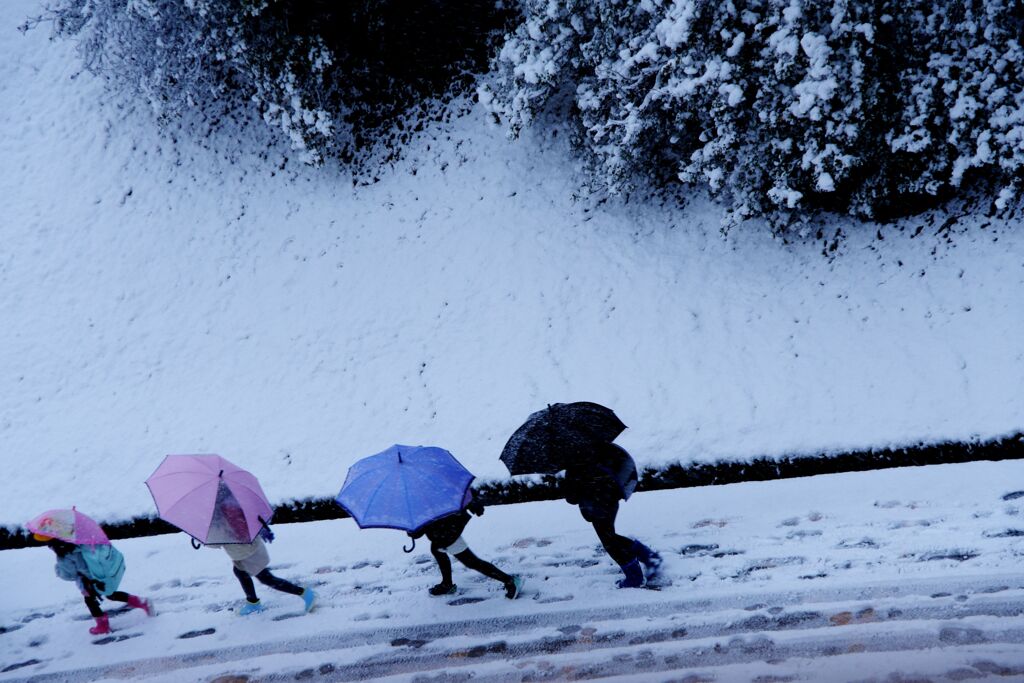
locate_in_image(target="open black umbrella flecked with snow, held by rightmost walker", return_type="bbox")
[502,401,626,474]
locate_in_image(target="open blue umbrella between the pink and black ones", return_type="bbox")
[335,443,475,531]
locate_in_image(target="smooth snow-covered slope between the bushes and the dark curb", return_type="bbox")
[0,0,1024,524]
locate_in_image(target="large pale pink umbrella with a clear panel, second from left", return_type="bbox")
[145,456,273,544]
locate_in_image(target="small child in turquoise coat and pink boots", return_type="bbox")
[33,533,153,636]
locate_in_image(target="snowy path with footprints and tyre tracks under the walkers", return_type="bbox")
[0,462,1024,682]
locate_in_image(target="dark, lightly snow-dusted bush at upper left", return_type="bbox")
[26,0,506,163]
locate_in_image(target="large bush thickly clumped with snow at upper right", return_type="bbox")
[479,0,1024,226]
